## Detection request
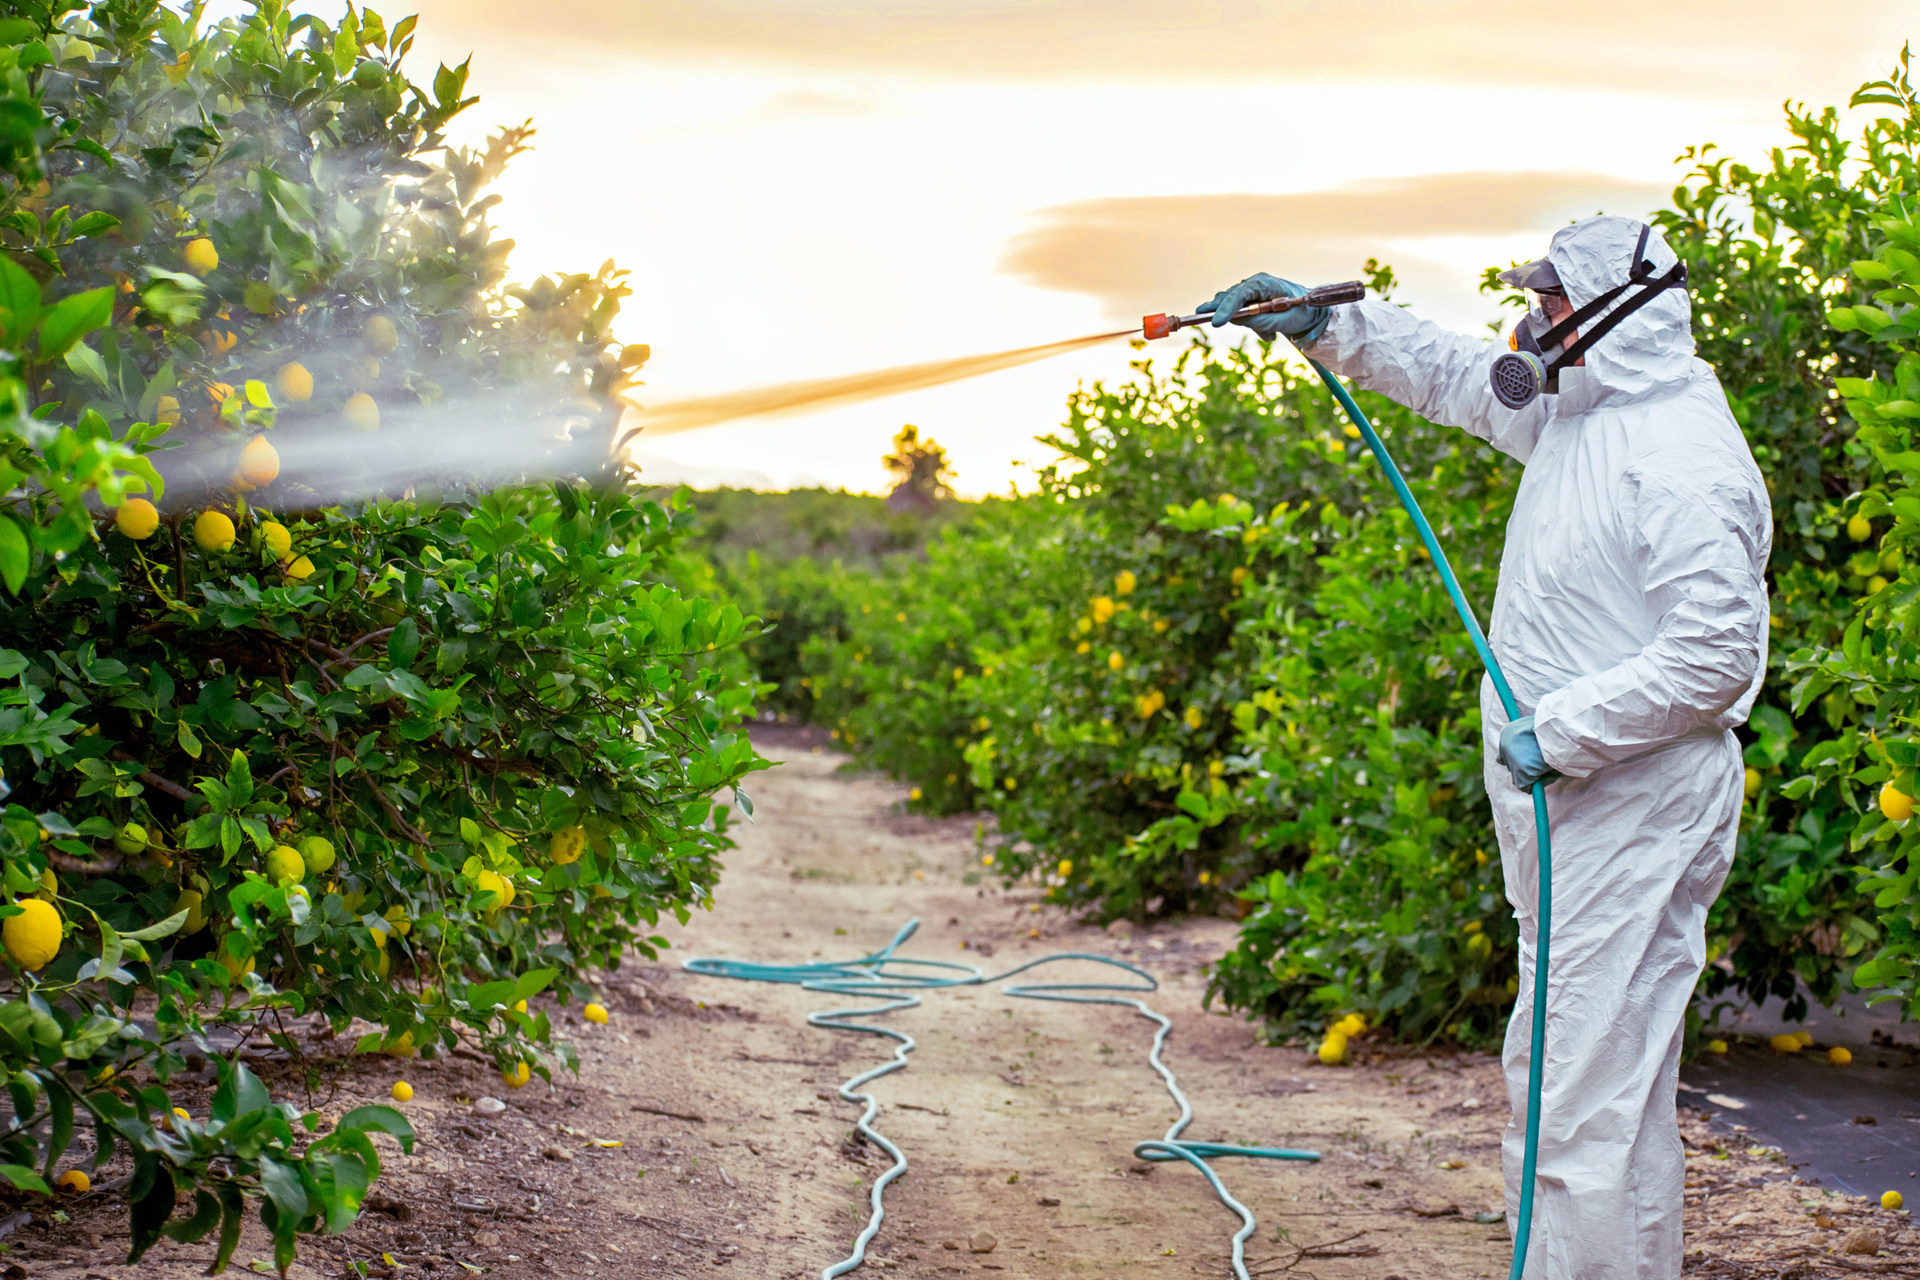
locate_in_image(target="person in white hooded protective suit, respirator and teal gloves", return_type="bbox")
[1202,217,1772,1280]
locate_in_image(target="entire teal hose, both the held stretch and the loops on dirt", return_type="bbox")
[685,343,1553,1280]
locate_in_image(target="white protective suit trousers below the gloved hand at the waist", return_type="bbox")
[1488,729,1743,1280]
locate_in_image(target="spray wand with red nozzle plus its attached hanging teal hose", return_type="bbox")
[1140,280,1553,1280]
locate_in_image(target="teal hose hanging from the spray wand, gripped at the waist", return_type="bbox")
[1308,357,1553,1280]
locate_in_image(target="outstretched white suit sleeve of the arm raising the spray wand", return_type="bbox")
[1302,297,1549,462]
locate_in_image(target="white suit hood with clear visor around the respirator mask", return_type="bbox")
[1501,215,1693,403]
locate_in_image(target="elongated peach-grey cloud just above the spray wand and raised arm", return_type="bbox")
[1000,173,1668,319]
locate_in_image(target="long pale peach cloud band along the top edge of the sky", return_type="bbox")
[408,0,1908,96]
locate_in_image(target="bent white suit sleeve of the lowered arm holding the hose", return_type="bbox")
[1534,472,1768,777]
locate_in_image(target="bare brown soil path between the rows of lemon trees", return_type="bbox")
[15,731,1920,1280]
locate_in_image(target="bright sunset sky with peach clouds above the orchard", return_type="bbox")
[215,0,1920,493]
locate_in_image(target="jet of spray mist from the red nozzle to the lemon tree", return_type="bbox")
[154,330,1139,509]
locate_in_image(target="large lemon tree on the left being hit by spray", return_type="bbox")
[0,0,762,1270]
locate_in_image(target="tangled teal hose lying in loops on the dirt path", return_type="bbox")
[684,919,1319,1280]
